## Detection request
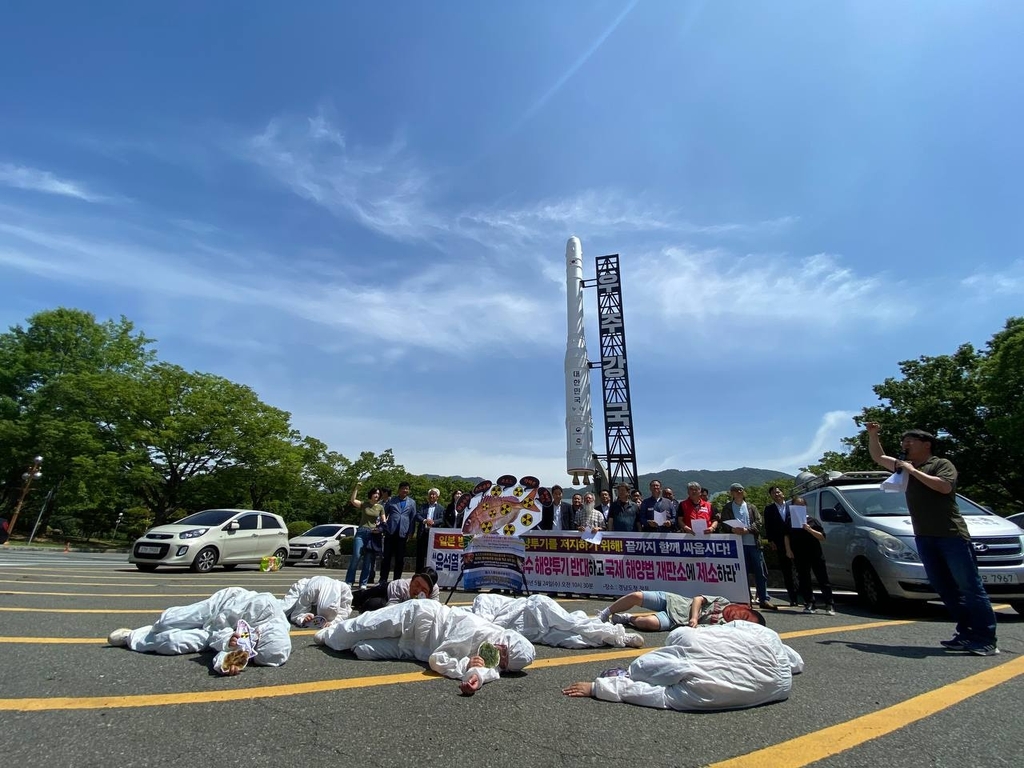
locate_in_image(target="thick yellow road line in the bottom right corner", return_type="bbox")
[709,656,1024,768]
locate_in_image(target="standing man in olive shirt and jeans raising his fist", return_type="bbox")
[865,422,999,656]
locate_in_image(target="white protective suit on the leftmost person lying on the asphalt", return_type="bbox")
[128,587,292,671]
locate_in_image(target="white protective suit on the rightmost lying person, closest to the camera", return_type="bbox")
[592,622,804,710]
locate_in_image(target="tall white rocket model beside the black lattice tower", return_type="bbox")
[565,238,594,485]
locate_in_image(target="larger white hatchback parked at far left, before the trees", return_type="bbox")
[128,509,288,573]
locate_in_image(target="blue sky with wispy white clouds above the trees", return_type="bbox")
[0,0,1024,483]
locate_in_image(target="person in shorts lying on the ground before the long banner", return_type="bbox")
[597,591,765,632]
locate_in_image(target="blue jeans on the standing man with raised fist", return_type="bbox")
[914,536,995,645]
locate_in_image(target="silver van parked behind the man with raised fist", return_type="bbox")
[792,472,1024,613]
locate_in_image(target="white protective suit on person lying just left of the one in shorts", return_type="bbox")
[471,593,629,648]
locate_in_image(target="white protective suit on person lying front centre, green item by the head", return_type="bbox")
[313,600,534,683]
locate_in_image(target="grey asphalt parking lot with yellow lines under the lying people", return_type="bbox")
[0,549,1024,768]
